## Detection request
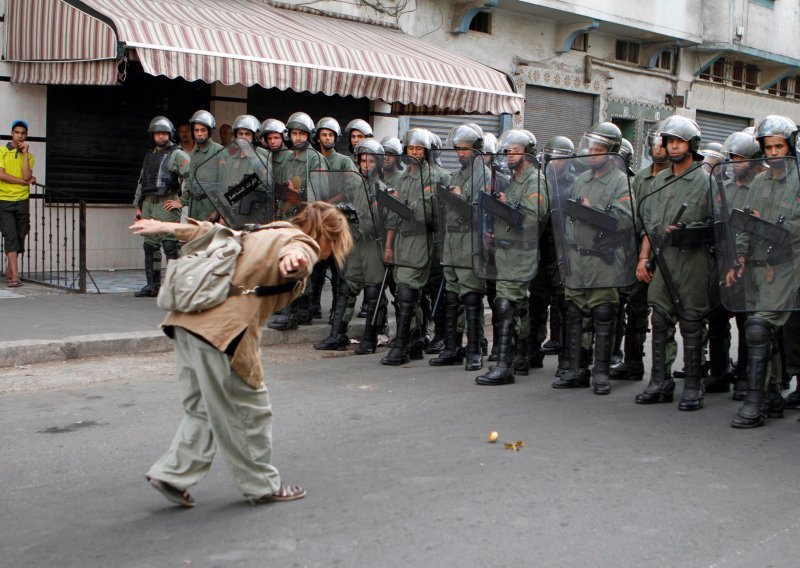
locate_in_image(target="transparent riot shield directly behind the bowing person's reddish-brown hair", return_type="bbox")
[308,170,385,285]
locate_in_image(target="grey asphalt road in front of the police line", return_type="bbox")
[0,346,800,568]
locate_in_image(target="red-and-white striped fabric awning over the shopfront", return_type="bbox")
[6,0,523,114]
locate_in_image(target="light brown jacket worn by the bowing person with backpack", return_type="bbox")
[161,219,319,388]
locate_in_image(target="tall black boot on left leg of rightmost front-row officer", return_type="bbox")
[731,318,772,428]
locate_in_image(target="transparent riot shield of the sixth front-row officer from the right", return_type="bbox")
[370,156,434,268]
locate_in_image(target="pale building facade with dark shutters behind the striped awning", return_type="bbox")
[0,0,800,268]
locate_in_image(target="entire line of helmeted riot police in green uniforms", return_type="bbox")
[134,110,800,428]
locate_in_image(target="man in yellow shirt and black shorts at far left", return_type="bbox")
[0,120,36,288]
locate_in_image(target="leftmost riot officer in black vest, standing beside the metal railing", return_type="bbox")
[133,116,190,297]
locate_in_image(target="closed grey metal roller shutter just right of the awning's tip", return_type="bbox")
[524,85,595,148]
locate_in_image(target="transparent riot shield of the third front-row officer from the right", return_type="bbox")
[544,154,638,290]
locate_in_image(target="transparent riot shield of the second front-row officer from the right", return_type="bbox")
[637,162,719,321]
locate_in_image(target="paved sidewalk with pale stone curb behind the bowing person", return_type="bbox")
[0,270,364,368]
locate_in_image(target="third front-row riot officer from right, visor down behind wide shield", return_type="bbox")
[548,122,636,395]
